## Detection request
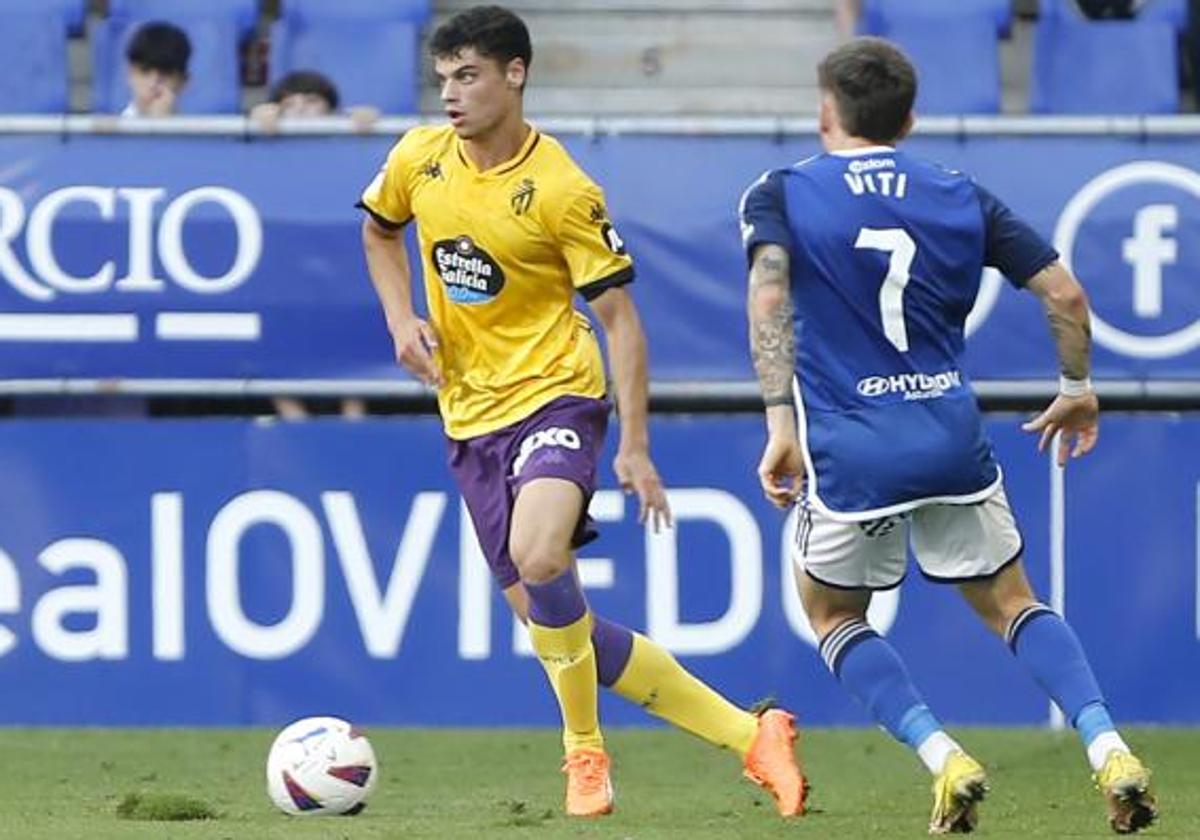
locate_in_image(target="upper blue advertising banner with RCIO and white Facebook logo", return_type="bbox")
[0,134,1200,382]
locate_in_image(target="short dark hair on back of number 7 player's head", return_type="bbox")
[817,37,917,143]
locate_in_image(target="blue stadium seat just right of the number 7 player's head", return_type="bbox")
[883,17,1001,115]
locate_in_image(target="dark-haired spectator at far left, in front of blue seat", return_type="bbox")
[121,20,192,116]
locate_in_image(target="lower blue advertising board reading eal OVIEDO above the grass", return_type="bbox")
[0,415,1200,725]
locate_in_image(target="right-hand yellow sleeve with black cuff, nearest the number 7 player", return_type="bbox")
[549,182,634,300]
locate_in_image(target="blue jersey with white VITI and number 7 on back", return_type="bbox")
[740,146,1058,520]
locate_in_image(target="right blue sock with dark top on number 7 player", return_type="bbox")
[1006,604,1116,745]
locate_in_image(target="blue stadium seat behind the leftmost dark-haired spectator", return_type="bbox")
[92,0,258,114]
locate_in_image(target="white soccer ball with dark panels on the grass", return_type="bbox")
[266,718,379,816]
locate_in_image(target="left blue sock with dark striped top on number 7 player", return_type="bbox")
[821,620,942,749]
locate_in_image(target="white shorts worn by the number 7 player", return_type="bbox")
[792,487,1022,589]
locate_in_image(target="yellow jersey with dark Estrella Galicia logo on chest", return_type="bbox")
[359,126,634,439]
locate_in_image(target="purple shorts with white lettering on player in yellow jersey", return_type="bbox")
[449,396,610,589]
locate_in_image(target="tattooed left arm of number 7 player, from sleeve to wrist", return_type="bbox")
[749,245,796,404]
